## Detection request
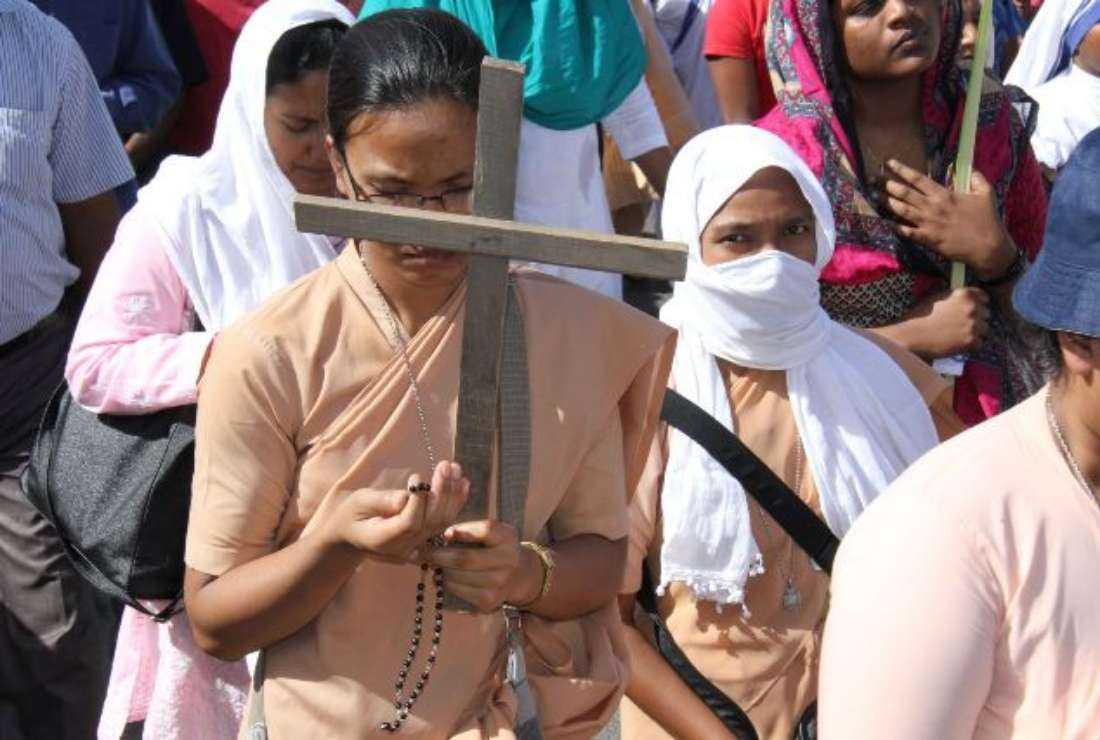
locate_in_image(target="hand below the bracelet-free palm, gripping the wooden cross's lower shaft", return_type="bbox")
[427,520,542,614]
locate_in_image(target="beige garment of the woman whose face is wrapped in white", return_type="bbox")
[622,332,963,740]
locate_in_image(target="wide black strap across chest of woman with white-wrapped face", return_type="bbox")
[661,389,840,573]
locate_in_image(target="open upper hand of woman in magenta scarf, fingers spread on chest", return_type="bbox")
[886,159,1016,280]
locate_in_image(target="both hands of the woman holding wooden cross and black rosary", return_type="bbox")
[323,461,538,612]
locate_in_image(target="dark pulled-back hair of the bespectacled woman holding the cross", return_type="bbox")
[328,9,485,151]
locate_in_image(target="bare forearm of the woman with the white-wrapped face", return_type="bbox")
[624,625,730,740]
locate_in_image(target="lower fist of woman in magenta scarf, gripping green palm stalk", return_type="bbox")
[895,288,990,360]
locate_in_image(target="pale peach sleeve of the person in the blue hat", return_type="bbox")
[817,476,1002,740]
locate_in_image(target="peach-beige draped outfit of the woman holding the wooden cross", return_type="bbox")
[186,248,674,738]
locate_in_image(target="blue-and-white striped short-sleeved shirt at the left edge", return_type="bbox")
[0,0,134,344]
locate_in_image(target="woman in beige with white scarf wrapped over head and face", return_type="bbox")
[620,126,961,738]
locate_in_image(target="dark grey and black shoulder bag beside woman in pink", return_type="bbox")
[22,322,202,621]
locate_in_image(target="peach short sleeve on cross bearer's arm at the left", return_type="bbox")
[185,325,301,576]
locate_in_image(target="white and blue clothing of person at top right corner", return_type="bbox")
[1004,0,1100,169]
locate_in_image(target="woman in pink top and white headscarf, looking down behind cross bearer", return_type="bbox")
[65,0,353,740]
